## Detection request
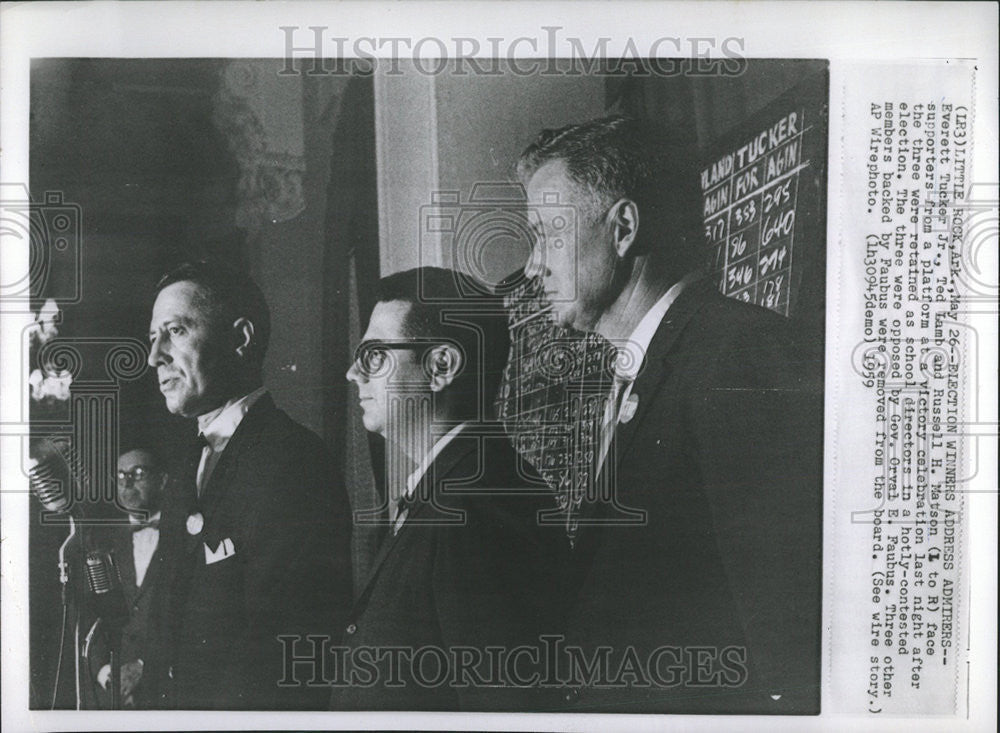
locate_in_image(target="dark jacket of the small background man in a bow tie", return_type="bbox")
[88,525,163,707]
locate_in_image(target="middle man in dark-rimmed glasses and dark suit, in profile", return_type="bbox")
[331,267,569,710]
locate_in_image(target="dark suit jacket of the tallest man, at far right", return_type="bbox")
[563,280,823,713]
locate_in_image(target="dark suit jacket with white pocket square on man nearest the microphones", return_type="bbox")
[144,395,351,709]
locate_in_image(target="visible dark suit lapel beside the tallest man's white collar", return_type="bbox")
[611,277,715,463]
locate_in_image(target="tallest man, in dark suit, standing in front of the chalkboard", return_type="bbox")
[518,117,823,713]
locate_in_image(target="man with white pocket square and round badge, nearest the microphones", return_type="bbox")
[148,263,351,709]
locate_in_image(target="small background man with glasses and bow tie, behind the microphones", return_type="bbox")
[90,448,169,708]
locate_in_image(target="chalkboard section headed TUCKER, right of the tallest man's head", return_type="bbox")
[699,70,828,316]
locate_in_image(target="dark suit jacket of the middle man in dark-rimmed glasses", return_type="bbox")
[330,427,569,710]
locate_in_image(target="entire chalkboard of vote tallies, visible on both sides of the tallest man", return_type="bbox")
[497,69,828,538]
